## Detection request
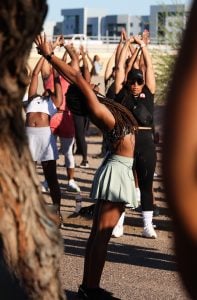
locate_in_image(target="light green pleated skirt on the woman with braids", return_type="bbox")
[91,155,139,208]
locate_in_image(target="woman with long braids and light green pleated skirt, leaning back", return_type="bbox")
[35,36,138,300]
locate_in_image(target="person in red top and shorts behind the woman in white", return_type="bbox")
[41,36,80,192]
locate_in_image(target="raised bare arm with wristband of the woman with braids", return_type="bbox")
[35,36,115,130]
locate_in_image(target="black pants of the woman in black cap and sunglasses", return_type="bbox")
[134,130,156,211]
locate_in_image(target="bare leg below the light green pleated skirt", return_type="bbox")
[83,200,124,288]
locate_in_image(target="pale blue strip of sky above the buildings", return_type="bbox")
[46,0,190,22]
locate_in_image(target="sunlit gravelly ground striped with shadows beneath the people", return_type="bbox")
[38,126,190,300]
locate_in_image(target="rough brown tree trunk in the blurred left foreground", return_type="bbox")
[0,0,64,300]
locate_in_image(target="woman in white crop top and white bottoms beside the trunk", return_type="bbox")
[25,57,62,225]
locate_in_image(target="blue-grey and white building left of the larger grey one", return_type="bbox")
[54,8,149,38]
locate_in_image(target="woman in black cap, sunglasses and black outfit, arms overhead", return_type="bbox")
[115,36,157,238]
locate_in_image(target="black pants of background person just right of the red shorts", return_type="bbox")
[73,115,89,161]
